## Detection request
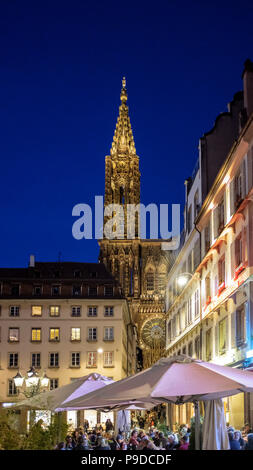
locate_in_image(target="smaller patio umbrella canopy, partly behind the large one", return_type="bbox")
[13,373,114,411]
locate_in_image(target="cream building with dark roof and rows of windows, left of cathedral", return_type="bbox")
[0,257,136,428]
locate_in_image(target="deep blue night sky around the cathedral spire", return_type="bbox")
[0,0,253,267]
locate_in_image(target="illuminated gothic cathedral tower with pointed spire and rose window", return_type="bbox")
[99,78,170,366]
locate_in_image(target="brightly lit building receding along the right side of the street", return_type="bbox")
[166,61,253,428]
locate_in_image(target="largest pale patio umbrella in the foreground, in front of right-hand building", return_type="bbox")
[60,355,253,448]
